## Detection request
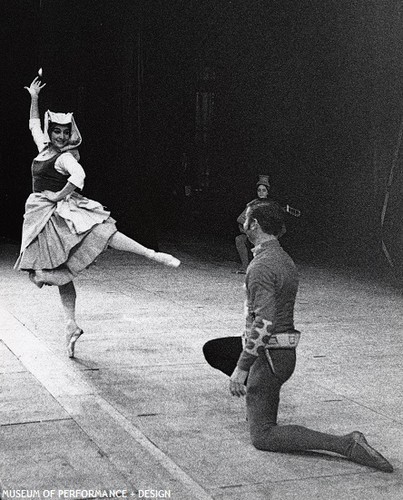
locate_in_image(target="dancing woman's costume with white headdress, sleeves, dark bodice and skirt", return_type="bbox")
[14,111,117,286]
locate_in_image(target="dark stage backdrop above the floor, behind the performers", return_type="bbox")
[0,0,403,270]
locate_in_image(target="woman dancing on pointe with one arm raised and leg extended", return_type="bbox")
[15,78,180,358]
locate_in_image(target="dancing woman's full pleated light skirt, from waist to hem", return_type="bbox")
[14,193,117,278]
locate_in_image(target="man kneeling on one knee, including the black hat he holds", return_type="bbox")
[203,201,393,472]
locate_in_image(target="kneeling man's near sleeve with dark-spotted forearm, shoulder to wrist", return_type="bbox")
[238,266,276,371]
